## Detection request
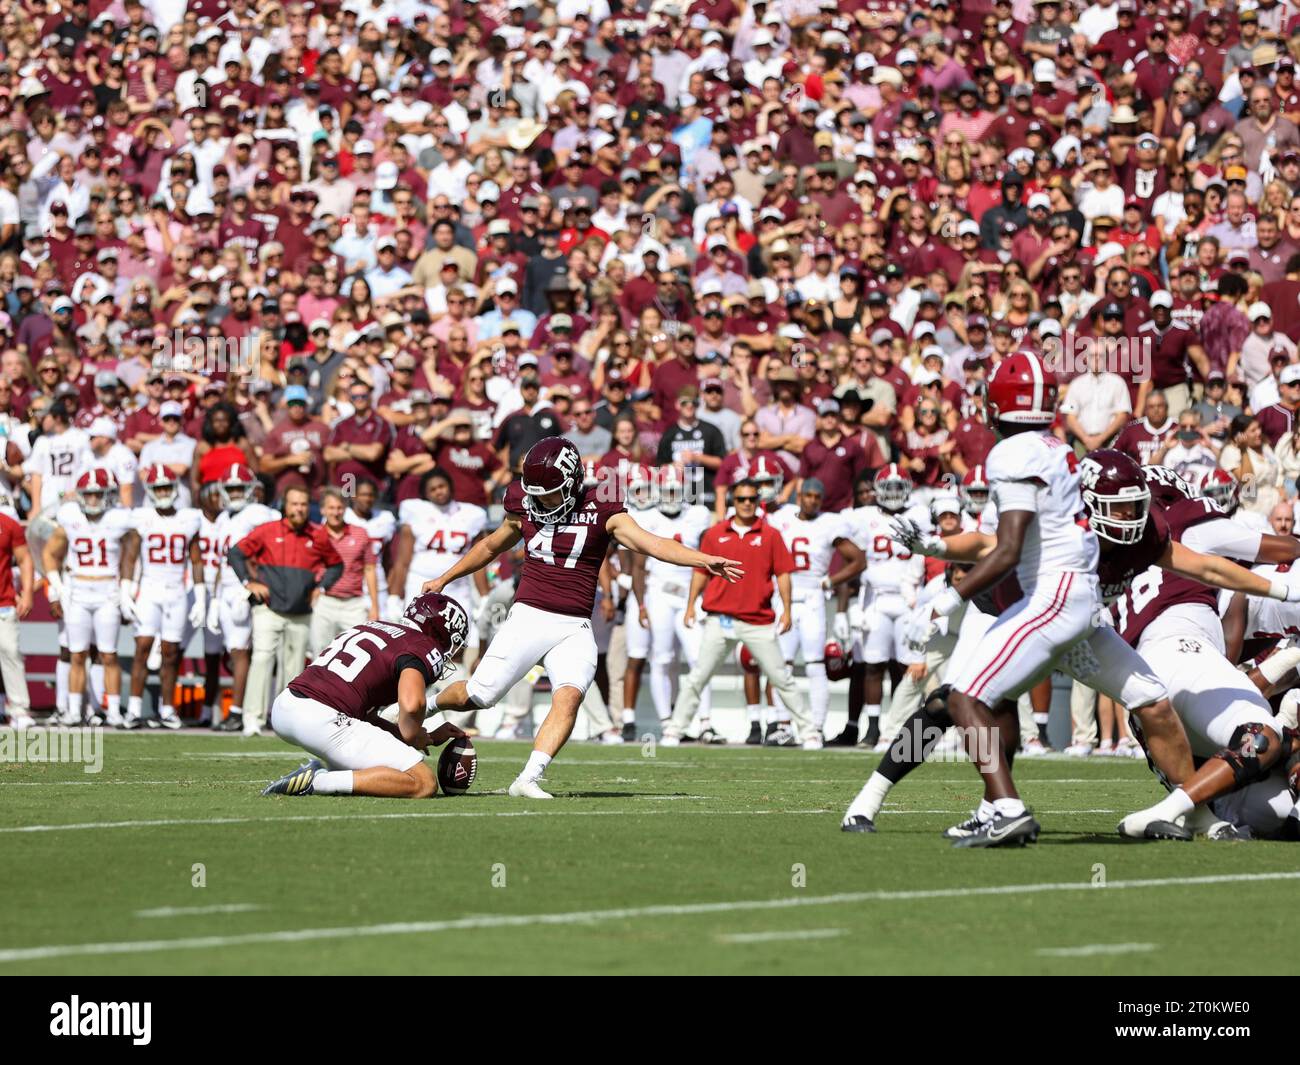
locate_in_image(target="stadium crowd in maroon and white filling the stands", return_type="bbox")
[0,0,1300,753]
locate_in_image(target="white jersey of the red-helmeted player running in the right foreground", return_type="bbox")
[984,432,1101,594]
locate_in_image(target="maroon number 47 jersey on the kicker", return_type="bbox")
[504,480,624,618]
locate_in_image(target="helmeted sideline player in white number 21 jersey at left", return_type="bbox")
[43,469,139,726]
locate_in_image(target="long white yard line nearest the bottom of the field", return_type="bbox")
[0,873,1300,964]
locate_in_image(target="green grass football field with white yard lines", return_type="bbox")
[0,733,1300,974]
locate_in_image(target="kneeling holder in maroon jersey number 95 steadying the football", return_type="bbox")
[263,593,469,798]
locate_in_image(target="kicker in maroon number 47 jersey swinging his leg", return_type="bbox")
[424,437,744,798]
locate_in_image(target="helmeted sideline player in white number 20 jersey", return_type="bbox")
[122,463,208,728]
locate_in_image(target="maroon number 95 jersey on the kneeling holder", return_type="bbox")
[284,622,443,728]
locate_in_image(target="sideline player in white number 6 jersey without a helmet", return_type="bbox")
[769,477,867,750]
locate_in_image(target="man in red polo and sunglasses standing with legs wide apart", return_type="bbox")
[663,481,806,749]
